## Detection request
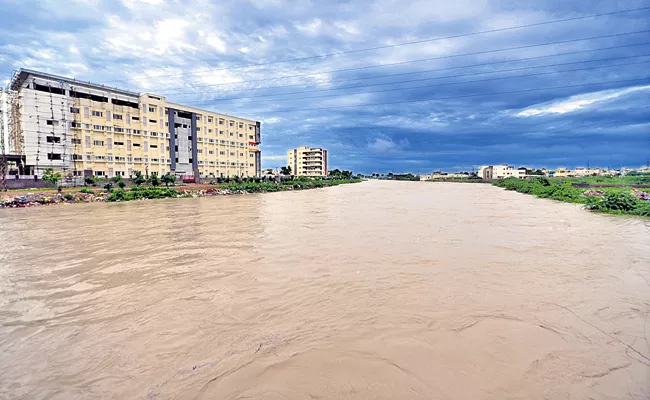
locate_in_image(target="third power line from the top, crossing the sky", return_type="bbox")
[161,42,650,95]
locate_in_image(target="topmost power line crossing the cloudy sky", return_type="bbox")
[100,6,650,83]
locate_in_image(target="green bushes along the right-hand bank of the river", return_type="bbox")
[492,177,650,217]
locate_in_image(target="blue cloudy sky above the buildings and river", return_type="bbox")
[0,0,650,173]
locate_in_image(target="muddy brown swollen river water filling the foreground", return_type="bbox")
[0,181,650,400]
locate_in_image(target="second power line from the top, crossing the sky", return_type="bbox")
[153,29,650,94]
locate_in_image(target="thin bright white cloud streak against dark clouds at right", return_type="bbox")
[515,85,650,117]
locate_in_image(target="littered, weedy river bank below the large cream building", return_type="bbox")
[0,179,361,208]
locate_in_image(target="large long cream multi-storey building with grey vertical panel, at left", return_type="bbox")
[5,70,261,178]
